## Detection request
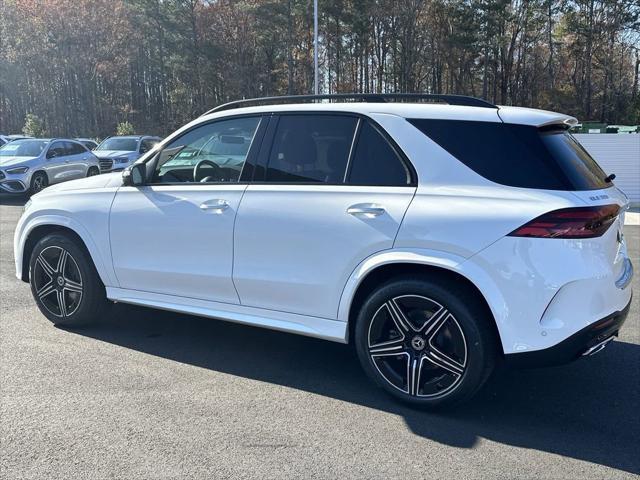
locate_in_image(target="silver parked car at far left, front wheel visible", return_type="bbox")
[0,138,100,194]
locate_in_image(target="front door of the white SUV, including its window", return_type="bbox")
[110,117,261,303]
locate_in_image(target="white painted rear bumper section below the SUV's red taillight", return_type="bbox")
[460,219,633,355]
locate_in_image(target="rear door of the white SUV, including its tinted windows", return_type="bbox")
[233,113,416,318]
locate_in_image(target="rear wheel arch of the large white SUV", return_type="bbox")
[339,254,504,354]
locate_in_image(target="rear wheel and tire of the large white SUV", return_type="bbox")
[355,276,498,409]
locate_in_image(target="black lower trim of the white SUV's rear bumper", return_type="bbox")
[505,300,631,368]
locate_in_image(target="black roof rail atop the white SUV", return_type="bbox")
[202,93,498,115]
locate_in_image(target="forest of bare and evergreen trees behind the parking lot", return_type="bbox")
[0,0,640,137]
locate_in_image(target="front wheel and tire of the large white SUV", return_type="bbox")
[29,233,108,327]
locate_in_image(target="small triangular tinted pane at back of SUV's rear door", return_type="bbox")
[348,122,411,186]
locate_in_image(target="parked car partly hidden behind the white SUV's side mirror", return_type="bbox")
[93,135,162,173]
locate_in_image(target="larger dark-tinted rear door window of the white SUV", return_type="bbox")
[266,115,358,184]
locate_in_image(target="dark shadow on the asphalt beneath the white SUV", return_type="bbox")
[77,305,640,473]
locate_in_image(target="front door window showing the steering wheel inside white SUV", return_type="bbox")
[153,117,260,183]
